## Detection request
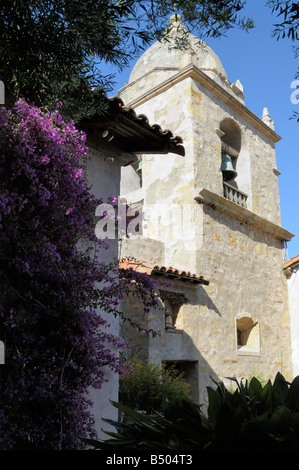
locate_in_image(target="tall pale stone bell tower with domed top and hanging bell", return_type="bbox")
[119,15,293,394]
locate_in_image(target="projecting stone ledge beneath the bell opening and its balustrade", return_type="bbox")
[195,188,294,241]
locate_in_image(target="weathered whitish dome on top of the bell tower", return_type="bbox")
[129,15,227,83]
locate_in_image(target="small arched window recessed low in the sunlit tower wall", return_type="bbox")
[236,316,260,354]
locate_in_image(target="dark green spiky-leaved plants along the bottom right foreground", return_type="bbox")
[88,373,299,451]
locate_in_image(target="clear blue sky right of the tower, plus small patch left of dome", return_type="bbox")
[107,0,299,258]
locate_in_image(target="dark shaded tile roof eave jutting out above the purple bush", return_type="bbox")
[80,94,185,156]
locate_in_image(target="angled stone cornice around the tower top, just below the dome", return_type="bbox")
[122,64,281,143]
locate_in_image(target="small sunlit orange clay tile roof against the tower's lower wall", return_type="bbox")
[119,259,209,285]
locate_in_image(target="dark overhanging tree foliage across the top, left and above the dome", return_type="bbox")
[0,0,252,120]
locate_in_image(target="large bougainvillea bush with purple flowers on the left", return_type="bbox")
[0,100,159,450]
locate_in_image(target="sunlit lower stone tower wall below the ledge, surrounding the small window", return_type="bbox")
[197,206,292,386]
